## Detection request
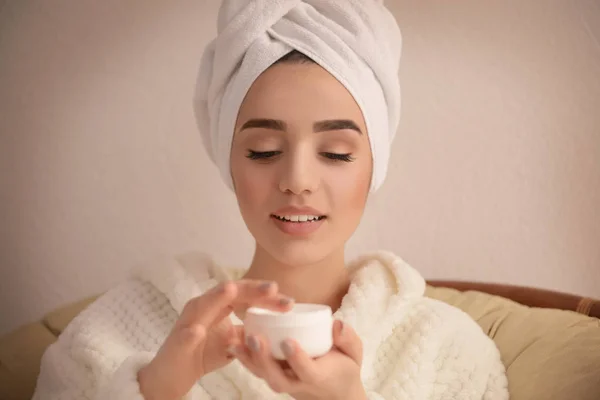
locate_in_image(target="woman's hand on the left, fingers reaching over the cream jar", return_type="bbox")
[138,280,293,400]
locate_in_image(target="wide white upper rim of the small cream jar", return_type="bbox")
[244,303,332,326]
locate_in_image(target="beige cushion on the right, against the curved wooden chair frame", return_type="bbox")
[426,287,600,400]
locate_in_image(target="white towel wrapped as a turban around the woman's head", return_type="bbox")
[194,0,401,191]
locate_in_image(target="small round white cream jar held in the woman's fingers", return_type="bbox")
[244,303,333,360]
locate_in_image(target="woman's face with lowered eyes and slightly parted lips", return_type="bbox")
[231,63,372,265]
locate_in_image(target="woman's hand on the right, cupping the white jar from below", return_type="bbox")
[232,321,367,400]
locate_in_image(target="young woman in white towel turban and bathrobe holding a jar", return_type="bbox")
[34,0,508,400]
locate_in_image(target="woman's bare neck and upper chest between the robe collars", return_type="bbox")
[244,246,350,312]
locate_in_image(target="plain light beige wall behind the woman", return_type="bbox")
[0,0,600,332]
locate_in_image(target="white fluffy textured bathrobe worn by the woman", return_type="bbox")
[33,252,509,400]
